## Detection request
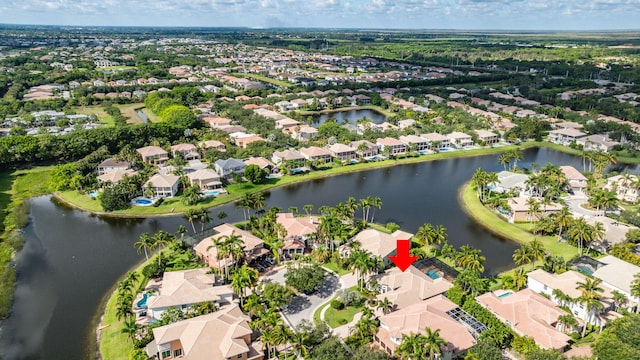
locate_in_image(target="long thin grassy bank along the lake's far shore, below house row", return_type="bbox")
[55,146,517,217]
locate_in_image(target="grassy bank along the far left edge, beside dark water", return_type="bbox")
[0,167,50,319]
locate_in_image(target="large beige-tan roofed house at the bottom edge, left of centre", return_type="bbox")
[146,304,264,360]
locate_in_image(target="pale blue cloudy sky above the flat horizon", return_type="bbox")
[0,0,640,30]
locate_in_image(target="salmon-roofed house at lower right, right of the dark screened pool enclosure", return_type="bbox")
[476,289,571,351]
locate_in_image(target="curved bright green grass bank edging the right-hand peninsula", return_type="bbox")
[458,183,578,260]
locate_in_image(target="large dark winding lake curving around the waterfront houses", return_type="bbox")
[0,149,638,360]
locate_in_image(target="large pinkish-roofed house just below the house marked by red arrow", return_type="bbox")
[374,295,486,359]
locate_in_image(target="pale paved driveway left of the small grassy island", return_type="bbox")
[263,268,340,328]
